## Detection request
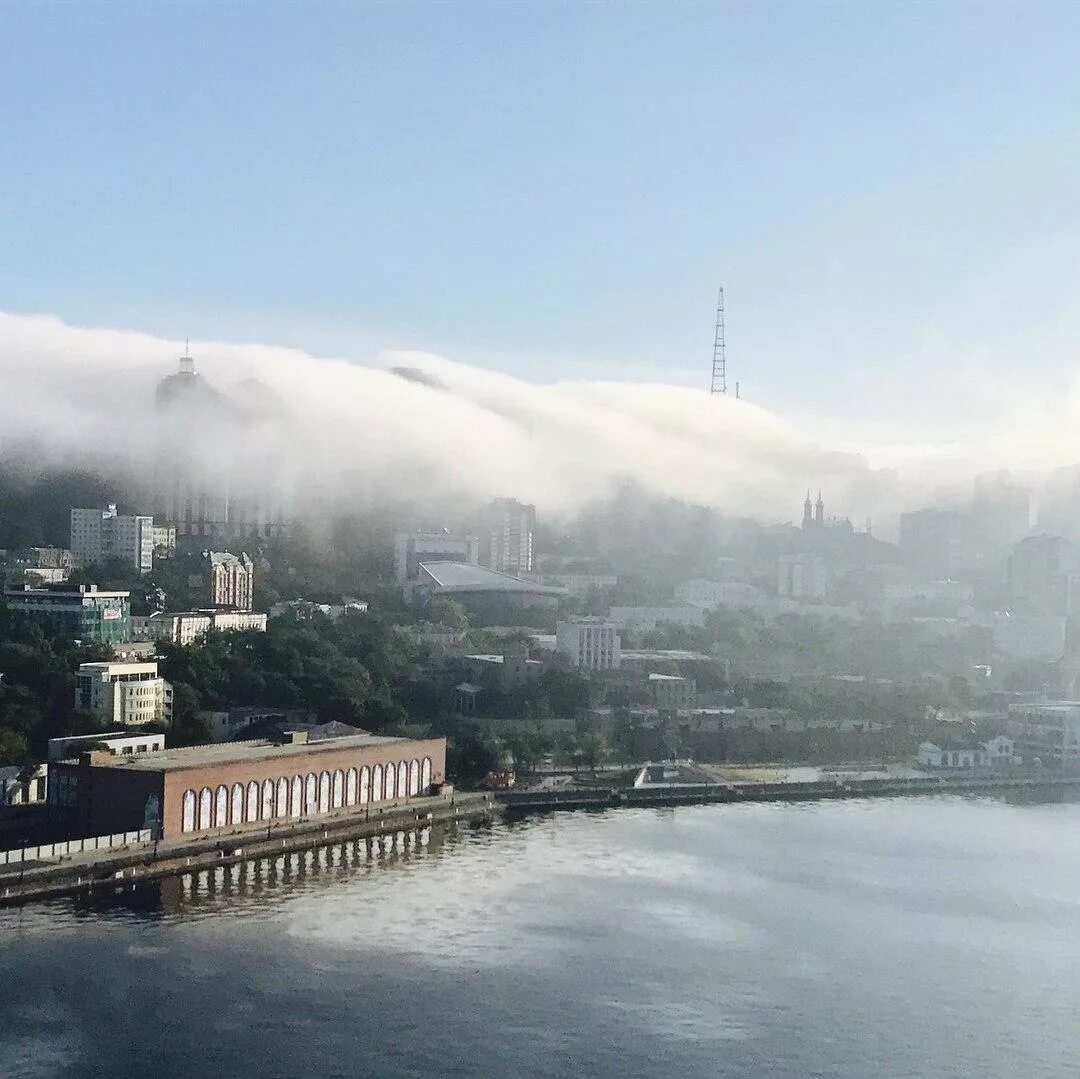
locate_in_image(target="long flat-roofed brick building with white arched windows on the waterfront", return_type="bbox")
[50,732,446,839]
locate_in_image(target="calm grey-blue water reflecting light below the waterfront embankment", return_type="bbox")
[0,798,1080,1079]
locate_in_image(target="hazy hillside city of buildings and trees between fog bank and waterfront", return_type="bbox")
[0,355,1080,838]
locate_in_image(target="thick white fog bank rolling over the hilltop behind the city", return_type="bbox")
[0,314,1068,529]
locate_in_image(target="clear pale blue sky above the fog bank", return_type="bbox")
[0,2,1080,429]
